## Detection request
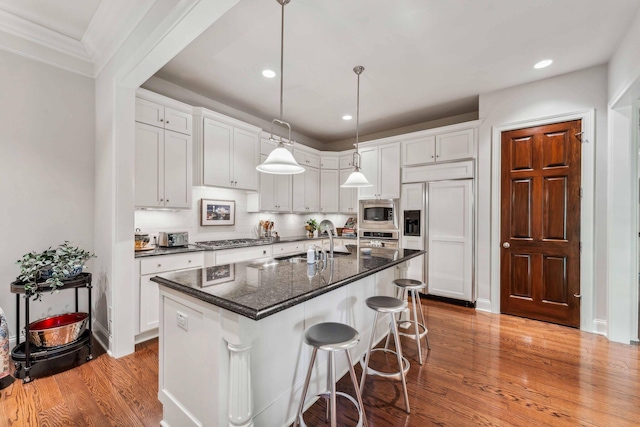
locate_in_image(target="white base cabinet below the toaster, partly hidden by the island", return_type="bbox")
[136,252,204,340]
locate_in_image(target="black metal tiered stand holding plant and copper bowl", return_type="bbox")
[11,273,93,383]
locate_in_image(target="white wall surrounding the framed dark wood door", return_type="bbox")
[477,65,607,329]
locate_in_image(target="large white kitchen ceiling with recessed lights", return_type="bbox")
[156,0,640,141]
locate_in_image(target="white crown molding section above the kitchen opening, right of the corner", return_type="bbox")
[82,0,157,76]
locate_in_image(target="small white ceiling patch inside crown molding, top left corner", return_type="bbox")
[0,0,102,40]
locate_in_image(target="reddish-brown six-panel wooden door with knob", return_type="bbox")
[500,120,582,327]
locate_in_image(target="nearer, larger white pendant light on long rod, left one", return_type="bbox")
[256,0,304,175]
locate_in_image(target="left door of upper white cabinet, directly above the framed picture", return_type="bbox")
[203,118,233,187]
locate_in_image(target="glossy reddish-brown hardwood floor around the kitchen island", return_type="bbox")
[0,301,640,427]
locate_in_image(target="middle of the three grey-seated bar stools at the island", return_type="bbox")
[360,296,410,414]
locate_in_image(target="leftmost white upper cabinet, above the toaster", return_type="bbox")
[134,91,192,209]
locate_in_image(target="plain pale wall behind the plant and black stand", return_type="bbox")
[0,50,95,342]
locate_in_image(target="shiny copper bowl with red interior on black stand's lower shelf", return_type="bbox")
[29,313,89,348]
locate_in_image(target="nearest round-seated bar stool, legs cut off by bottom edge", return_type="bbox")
[293,322,368,427]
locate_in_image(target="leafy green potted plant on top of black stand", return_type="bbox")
[16,241,96,300]
